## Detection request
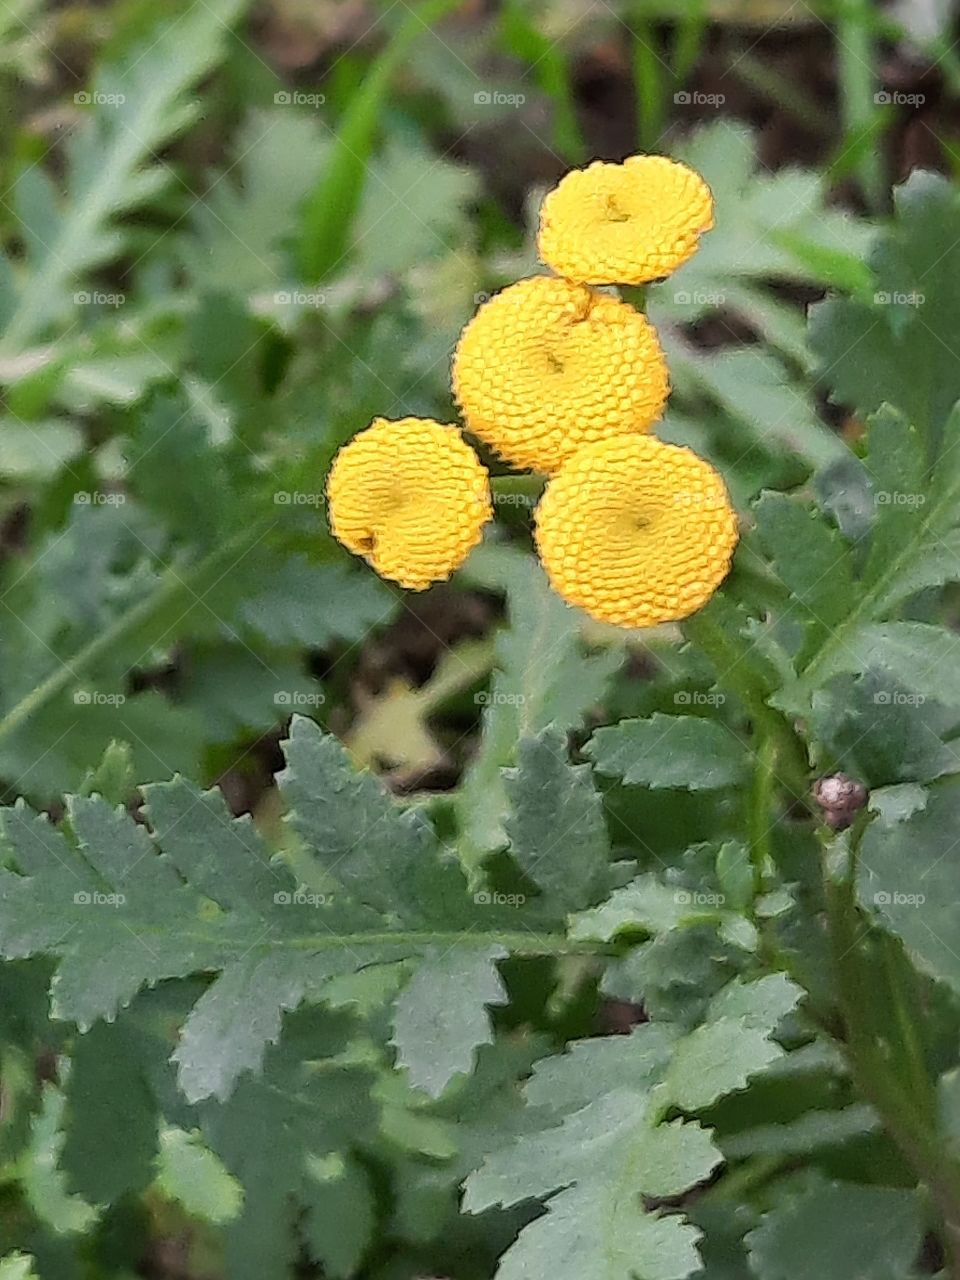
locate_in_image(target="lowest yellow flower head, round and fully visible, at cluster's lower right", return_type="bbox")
[536,435,737,627]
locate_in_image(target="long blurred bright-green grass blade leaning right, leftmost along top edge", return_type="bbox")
[300,0,458,280]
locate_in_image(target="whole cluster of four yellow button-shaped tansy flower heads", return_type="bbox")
[328,156,737,627]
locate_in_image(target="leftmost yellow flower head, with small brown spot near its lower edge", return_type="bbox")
[326,417,493,591]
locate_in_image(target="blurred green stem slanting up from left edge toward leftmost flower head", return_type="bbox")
[0,521,270,741]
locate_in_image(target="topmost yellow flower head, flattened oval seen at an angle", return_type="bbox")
[538,156,713,284]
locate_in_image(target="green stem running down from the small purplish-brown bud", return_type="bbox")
[824,824,960,1280]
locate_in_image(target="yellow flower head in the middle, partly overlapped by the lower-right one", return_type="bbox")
[453,275,669,472]
